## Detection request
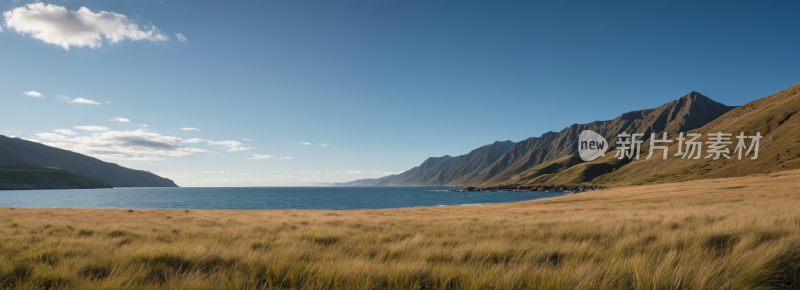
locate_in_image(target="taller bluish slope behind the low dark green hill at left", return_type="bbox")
[0,135,177,187]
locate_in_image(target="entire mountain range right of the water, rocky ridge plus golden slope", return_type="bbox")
[337,84,800,187]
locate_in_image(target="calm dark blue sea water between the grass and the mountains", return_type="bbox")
[0,187,565,210]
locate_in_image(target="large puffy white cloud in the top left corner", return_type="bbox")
[3,3,169,50]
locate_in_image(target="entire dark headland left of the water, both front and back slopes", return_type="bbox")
[0,135,178,188]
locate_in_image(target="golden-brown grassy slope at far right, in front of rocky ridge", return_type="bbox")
[573,83,800,185]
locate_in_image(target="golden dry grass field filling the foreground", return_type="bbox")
[0,170,800,289]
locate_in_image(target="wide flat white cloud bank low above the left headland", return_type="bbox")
[36,129,210,160]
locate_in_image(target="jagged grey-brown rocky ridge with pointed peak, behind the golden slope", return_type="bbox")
[341,92,734,186]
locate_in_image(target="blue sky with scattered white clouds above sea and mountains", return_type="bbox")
[0,0,800,187]
